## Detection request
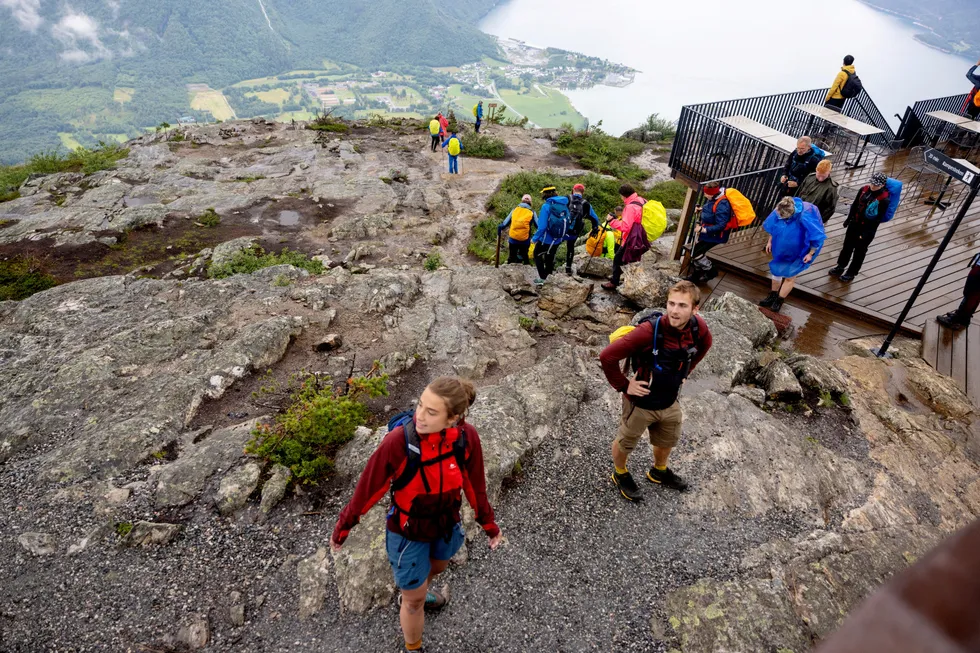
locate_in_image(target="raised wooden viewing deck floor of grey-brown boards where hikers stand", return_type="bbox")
[709,148,980,335]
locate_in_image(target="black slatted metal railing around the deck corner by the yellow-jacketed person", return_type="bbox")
[670,89,895,183]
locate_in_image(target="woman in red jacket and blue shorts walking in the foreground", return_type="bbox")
[330,376,502,651]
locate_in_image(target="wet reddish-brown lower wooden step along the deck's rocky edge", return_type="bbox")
[701,271,888,360]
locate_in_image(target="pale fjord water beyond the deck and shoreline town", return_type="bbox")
[480,0,973,134]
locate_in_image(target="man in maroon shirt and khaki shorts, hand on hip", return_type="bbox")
[599,281,711,501]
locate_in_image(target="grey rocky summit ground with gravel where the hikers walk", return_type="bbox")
[0,120,980,653]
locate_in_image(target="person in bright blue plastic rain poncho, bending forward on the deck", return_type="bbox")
[759,197,827,313]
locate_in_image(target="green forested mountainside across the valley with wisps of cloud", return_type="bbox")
[0,0,496,163]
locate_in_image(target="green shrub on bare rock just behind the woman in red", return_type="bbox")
[245,374,388,484]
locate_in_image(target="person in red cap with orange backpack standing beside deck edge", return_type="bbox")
[687,181,755,283]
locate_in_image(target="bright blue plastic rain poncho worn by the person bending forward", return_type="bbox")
[762,197,827,277]
